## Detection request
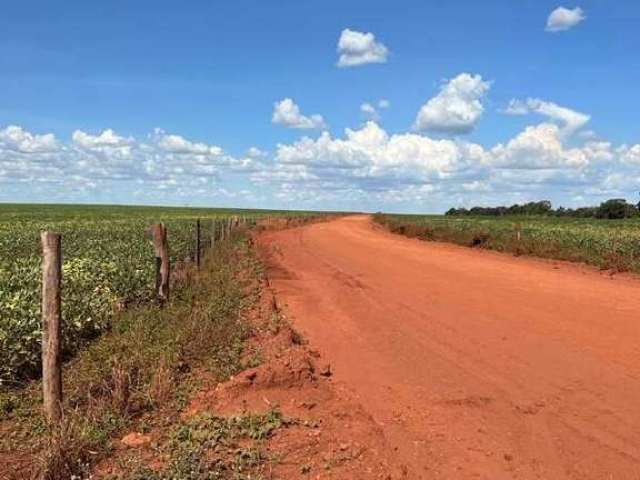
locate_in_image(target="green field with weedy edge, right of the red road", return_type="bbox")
[375,214,640,273]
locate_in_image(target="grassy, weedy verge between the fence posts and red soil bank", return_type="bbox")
[0,230,268,479]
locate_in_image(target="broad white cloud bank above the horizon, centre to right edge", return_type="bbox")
[252,111,640,208]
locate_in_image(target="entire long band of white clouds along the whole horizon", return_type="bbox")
[0,111,640,210]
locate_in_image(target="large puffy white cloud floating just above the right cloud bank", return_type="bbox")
[414,73,491,134]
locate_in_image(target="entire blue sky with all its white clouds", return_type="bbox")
[0,0,640,212]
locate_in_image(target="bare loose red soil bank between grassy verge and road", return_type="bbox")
[185,284,406,479]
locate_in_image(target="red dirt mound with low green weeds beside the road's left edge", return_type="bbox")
[95,251,406,480]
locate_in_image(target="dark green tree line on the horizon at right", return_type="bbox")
[445,198,640,219]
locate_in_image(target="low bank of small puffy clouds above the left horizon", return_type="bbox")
[0,126,264,200]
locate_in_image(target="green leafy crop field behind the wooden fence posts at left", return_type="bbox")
[0,204,316,386]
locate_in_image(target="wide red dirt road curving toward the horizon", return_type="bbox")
[259,216,640,480]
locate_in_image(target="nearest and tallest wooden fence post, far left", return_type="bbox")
[40,232,62,426]
